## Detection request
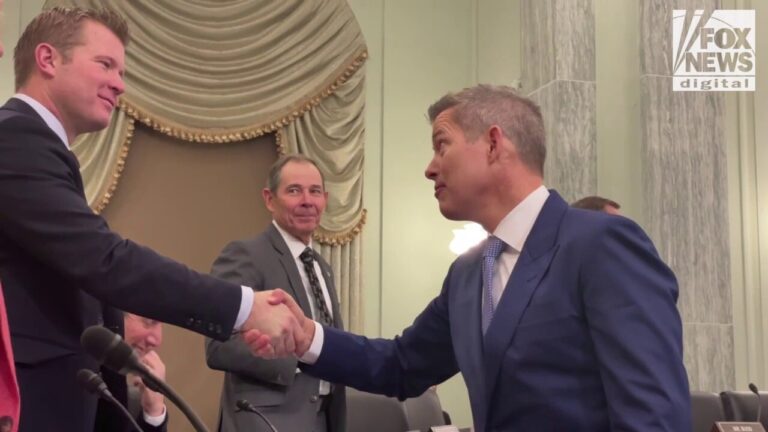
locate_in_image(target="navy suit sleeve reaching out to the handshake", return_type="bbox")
[300,267,459,400]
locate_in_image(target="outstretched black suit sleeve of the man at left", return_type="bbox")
[0,111,241,338]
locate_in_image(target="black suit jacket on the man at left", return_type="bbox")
[0,99,241,432]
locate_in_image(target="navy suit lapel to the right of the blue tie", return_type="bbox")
[478,191,568,401]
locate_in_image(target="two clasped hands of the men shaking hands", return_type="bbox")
[242,289,315,359]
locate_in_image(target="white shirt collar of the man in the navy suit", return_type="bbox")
[493,185,549,253]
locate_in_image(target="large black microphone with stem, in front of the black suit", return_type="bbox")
[80,326,208,432]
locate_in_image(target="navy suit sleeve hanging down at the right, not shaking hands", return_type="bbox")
[580,218,690,432]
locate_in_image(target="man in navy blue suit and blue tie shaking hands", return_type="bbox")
[255,85,691,432]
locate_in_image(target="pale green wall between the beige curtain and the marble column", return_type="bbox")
[348,0,520,426]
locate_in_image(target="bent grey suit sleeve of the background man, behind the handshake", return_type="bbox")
[205,242,297,386]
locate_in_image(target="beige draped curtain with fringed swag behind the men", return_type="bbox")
[45,0,367,331]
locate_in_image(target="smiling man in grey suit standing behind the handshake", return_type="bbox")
[206,154,345,432]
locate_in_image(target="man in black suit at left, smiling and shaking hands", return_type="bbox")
[0,8,304,432]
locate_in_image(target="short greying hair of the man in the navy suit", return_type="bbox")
[427,84,547,175]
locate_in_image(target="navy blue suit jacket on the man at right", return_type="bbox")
[302,191,691,432]
